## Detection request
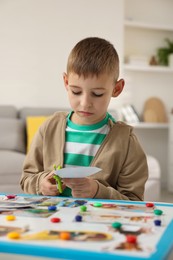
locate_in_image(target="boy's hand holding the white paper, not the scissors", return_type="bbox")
[63,178,98,198]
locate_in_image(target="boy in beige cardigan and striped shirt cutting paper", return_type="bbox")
[20,37,148,200]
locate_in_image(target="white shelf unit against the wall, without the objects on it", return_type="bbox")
[123,0,173,192]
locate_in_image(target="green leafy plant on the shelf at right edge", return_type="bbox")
[157,38,173,66]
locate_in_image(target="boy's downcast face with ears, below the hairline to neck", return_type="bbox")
[63,73,124,125]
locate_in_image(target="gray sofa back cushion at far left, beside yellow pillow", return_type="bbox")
[0,118,26,153]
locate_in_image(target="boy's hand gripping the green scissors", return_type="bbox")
[40,171,65,196]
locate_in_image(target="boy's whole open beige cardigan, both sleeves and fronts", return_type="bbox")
[20,112,148,200]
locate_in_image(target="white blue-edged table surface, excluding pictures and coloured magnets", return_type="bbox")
[0,194,173,260]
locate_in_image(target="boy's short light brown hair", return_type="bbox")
[67,37,119,82]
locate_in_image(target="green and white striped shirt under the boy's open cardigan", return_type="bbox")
[62,112,112,196]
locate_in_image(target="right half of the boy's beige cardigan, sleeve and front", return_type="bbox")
[90,126,148,201]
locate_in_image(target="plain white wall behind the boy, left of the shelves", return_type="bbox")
[0,0,123,107]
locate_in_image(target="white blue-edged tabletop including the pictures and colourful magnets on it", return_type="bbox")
[0,194,173,260]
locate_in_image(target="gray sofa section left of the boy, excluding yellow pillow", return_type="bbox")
[0,105,67,193]
